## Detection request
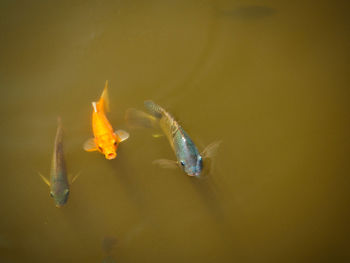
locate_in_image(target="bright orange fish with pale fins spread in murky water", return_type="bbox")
[84,80,129,160]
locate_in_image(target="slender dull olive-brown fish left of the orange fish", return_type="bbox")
[39,117,78,207]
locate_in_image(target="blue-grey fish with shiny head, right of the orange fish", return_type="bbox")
[126,100,221,177]
